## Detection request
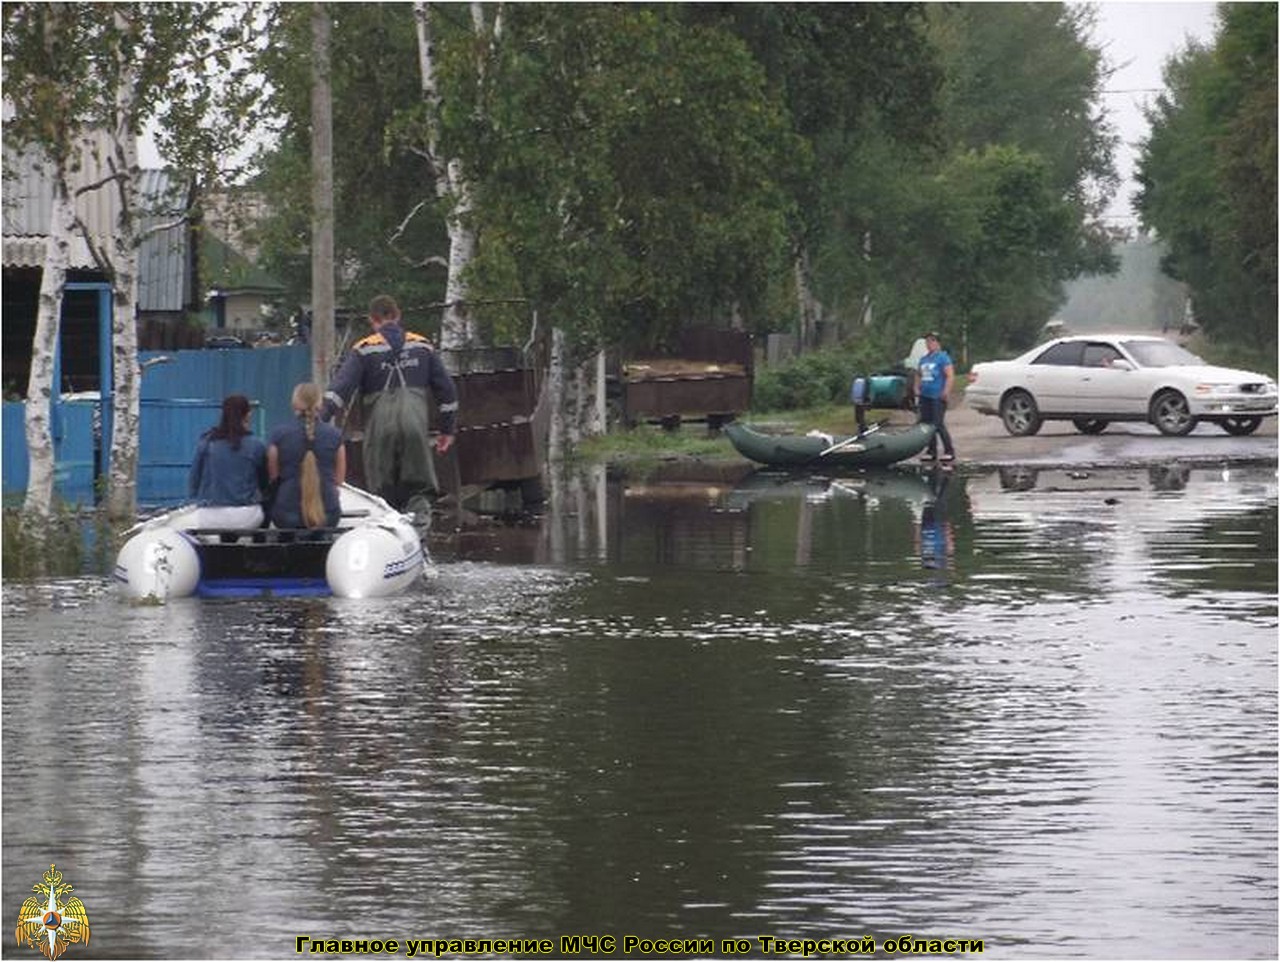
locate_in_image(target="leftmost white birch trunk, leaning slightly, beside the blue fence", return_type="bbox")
[23,165,76,518]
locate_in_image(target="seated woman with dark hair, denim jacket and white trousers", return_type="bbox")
[187,394,266,528]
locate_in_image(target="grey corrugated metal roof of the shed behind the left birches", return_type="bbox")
[3,133,191,311]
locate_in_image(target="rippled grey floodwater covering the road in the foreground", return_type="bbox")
[3,466,1277,962]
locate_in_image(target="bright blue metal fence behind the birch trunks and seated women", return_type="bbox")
[0,345,311,505]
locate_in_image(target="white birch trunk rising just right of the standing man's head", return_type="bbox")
[413,0,481,351]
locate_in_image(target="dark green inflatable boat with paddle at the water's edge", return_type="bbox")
[724,423,933,471]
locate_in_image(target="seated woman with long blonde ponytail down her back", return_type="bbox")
[266,382,347,528]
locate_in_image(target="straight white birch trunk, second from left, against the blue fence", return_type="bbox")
[106,8,142,521]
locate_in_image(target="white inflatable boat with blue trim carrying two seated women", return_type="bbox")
[115,485,426,600]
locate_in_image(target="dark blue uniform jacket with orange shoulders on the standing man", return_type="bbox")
[323,324,458,434]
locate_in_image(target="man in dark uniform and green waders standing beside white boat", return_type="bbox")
[323,294,458,522]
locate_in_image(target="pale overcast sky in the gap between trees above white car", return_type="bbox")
[1094,0,1217,226]
